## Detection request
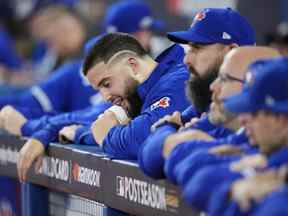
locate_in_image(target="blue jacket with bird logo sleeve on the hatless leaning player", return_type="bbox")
[103,45,189,159]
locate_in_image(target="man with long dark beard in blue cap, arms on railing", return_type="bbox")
[139,8,255,178]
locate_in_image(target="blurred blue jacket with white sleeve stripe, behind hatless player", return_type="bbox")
[0,61,100,118]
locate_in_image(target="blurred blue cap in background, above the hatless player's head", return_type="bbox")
[104,0,164,33]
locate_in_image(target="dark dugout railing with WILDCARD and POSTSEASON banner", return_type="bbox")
[0,133,196,216]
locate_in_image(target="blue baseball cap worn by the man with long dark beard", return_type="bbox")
[167,8,255,46]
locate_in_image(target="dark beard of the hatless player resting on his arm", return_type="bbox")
[126,80,143,119]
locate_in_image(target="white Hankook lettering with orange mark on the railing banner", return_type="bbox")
[72,163,101,187]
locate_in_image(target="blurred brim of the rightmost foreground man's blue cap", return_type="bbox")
[224,91,257,113]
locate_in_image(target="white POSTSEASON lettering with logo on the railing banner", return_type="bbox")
[116,176,167,210]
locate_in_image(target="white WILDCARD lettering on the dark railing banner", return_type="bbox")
[39,157,69,181]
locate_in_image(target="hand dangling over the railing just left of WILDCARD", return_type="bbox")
[17,139,44,182]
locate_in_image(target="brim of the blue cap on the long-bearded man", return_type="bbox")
[167,31,215,44]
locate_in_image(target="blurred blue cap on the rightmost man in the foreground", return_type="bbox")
[224,57,288,114]
